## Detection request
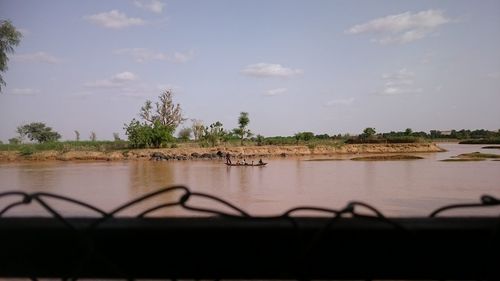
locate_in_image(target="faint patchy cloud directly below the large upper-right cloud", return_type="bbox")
[379,68,422,96]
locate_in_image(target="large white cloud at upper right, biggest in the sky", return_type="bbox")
[346,10,451,44]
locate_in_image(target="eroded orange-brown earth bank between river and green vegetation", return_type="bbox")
[0,143,444,162]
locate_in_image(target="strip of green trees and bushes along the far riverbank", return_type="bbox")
[0,90,500,155]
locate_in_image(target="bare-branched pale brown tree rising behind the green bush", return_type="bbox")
[140,90,186,129]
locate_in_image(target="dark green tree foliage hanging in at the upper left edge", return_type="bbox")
[0,20,22,92]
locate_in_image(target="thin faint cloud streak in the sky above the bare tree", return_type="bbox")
[114,48,194,63]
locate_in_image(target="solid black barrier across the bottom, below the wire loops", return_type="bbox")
[0,217,500,280]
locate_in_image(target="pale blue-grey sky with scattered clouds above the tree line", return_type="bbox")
[0,0,500,142]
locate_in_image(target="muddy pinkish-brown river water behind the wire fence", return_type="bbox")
[0,143,500,216]
